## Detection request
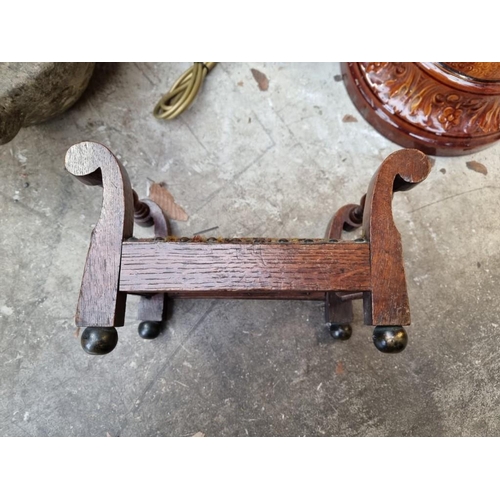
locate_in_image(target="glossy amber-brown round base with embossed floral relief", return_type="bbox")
[342,62,500,156]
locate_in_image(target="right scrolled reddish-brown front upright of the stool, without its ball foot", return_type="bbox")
[363,149,431,325]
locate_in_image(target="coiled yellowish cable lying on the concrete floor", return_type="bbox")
[153,63,217,120]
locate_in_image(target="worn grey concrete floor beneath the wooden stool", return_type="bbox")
[0,63,500,436]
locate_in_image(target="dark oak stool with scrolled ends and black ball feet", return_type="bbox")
[66,142,431,354]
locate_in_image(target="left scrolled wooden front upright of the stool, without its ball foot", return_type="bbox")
[66,142,134,326]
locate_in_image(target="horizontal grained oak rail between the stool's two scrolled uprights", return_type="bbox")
[120,241,370,296]
